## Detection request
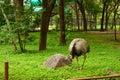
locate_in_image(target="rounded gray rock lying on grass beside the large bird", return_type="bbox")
[44,54,72,69]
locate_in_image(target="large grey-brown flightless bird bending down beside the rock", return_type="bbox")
[68,38,90,69]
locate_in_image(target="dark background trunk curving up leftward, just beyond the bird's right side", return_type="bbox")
[75,0,87,31]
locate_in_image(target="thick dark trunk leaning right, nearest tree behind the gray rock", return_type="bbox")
[39,0,55,50]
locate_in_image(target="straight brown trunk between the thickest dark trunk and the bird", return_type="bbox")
[59,0,66,45]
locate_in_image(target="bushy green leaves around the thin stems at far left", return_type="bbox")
[0,4,40,50]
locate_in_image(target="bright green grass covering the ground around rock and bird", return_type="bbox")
[0,31,120,80]
